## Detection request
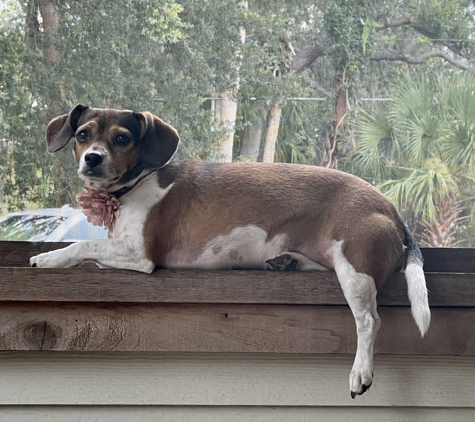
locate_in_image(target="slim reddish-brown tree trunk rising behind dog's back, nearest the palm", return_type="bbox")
[322,71,346,169]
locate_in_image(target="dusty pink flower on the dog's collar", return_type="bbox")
[76,187,120,232]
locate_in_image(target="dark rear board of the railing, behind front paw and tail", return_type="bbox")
[0,241,475,273]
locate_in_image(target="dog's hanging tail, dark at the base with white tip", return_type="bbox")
[404,226,430,337]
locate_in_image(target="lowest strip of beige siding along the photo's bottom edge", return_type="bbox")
[0,406,475,422]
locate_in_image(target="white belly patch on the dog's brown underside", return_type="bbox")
[166,225,287,270]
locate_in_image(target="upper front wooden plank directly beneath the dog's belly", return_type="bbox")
[0,265,475,307]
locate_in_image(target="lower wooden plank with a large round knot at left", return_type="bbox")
[0,302,475,356]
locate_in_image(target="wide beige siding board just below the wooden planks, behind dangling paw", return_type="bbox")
[0,352,475,407]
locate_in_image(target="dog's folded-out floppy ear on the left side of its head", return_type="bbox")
[46,104,89,152]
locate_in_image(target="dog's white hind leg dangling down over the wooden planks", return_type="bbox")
[333,241,381,398]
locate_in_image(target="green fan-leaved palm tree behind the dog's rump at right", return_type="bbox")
[353,73,475,247]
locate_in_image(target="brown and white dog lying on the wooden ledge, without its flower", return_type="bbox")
[30,105,430,397]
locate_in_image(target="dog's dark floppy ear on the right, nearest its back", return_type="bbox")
[134,111,180,168]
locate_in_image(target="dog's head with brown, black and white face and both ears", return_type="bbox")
[46,105,179,188]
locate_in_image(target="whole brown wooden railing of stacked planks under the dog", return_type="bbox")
[0,242,475,356]
